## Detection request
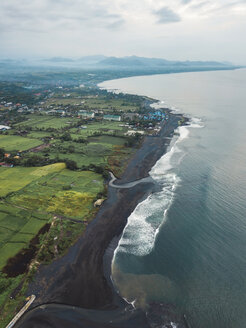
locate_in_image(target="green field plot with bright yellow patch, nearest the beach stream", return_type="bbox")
[8,169,103,218]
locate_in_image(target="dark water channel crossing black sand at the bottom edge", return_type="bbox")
[15,303,186,328]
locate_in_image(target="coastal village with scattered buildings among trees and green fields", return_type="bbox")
[0,82,168,168]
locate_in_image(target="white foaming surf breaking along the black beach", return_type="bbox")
[114,114,203,256]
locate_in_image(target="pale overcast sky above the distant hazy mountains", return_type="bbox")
[0,0,246,65]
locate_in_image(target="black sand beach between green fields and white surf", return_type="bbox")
[16,113,187,328]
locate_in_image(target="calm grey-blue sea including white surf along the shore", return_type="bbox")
[100,69,246,328]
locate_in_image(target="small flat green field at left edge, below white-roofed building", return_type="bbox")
[0,135,42,151]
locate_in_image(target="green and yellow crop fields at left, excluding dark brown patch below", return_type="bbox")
[0,163,103,269]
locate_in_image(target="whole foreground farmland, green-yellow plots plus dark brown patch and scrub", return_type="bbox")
[0,163,104,326]
